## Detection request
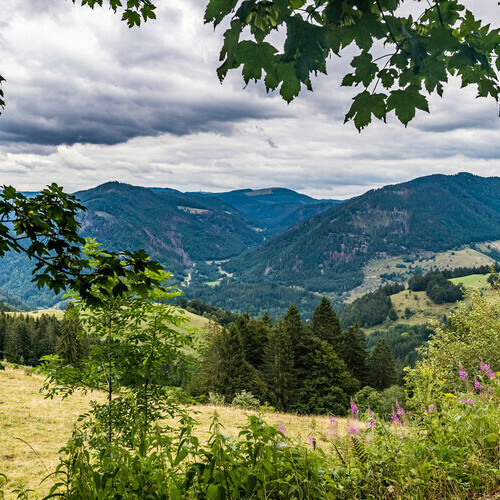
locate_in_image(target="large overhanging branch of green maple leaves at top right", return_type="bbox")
[205,0,500,130]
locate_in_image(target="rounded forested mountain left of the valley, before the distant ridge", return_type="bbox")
[75,182,262,273]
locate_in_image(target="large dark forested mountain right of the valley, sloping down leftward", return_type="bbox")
[226,173,500,293]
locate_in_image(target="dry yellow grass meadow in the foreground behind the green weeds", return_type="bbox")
[0,366,347,498]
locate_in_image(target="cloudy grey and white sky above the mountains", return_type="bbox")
[0,0,500,199]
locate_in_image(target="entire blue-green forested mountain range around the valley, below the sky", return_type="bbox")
[0,173,500,314]
